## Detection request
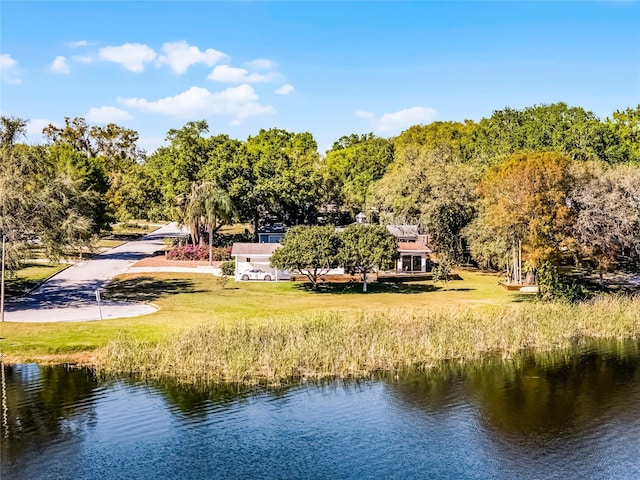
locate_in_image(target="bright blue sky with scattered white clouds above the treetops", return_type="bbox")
[0,0,640,152]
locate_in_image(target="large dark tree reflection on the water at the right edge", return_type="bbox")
[388,342,640,438]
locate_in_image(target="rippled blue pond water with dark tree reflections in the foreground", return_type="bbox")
[0,342,640,480]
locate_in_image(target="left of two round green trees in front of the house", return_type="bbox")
[271,225,339,290]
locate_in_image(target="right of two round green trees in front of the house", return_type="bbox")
[338,225,398,293]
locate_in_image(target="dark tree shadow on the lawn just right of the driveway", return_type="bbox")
[102,277,204,302]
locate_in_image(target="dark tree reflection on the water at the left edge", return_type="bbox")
[1,365,97,464]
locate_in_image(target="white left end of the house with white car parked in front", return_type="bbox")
[231,243,290,281]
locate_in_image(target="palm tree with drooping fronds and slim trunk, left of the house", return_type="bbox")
[184,182,237,265]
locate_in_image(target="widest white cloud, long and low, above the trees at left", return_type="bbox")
[118,84,275,125]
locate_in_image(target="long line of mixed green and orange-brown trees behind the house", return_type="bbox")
[0,103,640,286]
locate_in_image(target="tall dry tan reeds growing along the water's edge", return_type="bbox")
[96,296,640,386]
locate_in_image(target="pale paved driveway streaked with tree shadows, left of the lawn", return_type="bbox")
[5,223,188,322]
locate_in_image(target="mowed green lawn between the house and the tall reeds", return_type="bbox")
[0,271,530,361]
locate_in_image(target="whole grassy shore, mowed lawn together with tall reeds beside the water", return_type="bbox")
[0,271,640,385]
